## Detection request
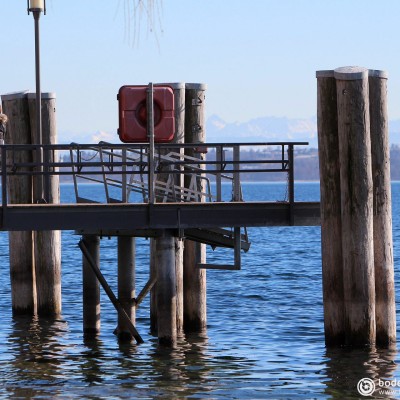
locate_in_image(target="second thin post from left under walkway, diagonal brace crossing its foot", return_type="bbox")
[117,236,136,340]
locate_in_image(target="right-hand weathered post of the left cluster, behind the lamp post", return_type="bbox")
[28,93,61,316]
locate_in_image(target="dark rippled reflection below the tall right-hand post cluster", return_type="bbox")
[324,346,397,399]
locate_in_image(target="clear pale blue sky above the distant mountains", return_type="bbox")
[0,0,400,140]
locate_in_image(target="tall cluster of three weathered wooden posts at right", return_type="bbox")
[317,67,396,346]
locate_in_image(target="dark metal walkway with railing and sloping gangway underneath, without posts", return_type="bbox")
[0,142,320,269]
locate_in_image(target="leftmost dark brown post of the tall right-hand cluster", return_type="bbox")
[316,70,345,346]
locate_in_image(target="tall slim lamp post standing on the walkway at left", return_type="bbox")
[27,0,48,202]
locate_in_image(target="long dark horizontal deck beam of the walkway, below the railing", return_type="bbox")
[0,202,320,236]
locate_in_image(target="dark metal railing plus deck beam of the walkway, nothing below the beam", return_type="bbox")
[0,142,319,236]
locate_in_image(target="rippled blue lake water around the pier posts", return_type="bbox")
[0,183,400,399]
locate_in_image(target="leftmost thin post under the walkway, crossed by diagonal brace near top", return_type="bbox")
[82,235,100,338]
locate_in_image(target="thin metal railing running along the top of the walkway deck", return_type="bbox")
[1,142,308,206]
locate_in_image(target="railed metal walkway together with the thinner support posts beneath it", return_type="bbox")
[0,139,320,345]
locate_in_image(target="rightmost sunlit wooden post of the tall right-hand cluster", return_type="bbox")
[368,70,396,346]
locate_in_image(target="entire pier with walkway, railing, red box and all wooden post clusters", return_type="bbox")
[0,67,396,346]
